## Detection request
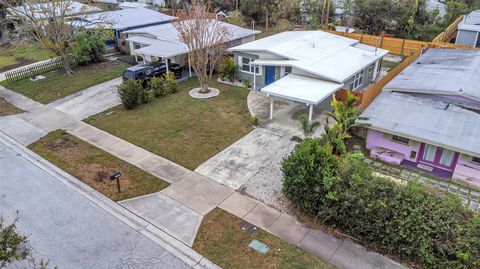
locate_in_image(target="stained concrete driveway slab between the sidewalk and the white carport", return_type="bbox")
[195,128,293,189]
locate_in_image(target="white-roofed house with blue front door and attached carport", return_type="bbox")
[230,31,388,119]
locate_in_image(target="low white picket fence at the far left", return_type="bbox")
[5,58,63,84]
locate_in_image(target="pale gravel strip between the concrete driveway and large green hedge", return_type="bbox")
[240,141,297,213]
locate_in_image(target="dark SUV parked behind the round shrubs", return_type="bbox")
[122,62,182,88]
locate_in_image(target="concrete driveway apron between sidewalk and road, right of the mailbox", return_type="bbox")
[119,192,203,246]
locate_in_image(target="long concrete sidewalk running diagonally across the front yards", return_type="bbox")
[0,87,404,269]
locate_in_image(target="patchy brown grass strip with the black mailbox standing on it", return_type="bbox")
[28,130,168,201]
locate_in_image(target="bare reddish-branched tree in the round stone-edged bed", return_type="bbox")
[173,1,231,93]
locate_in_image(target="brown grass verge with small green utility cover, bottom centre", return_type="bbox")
[193,208,336,269]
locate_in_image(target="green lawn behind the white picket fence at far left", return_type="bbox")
[0,44,48,72]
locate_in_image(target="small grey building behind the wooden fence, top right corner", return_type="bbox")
[455,10,480,47]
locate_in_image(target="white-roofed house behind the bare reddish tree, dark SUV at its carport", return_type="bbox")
[126,19,260,69]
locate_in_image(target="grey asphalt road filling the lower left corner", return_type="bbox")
[0,141,190,269]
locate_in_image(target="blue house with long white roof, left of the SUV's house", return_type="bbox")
[70,8,176,48]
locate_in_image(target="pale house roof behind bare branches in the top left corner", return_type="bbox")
[9,1,102,19]
